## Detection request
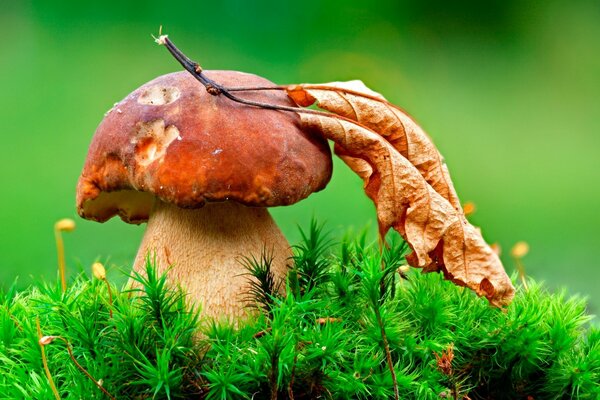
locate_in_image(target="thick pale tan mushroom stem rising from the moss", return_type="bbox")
[134,200,291,319]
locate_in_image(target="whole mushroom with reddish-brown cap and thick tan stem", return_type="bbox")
[77,71,332,318]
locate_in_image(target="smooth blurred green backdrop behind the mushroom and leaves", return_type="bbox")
[0,0,600,312]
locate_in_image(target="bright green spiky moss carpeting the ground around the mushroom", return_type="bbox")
[0,224,600,400]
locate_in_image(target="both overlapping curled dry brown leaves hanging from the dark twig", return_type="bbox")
[288,82,514,307]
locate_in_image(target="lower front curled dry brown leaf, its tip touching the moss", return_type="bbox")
[300,113,514,306]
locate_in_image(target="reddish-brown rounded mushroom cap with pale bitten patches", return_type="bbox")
[76,71,332,223]
